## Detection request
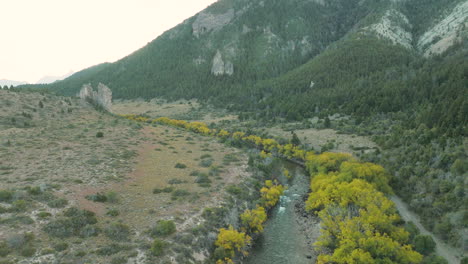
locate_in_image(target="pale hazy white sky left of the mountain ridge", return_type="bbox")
[0,0,216,83]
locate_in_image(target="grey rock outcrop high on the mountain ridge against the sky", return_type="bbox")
[192,9,235,38]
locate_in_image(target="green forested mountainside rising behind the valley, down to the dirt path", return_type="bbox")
[23,0,468,250]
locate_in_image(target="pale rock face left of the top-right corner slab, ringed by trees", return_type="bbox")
[369,9,413,49]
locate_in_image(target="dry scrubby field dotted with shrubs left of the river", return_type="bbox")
[0,91,249,263]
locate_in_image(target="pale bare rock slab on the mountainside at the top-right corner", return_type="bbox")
[417,1,468,56]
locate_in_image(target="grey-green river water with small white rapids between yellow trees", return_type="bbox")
[243,162,313,264]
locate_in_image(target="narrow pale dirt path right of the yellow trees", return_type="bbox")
[391,196,462,264]
